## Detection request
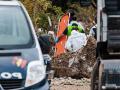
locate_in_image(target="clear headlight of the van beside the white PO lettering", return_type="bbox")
[25,61,46,87]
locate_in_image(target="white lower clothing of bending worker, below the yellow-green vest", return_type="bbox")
[65,30,87,52]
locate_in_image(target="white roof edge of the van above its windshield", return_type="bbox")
[0,0,20,6]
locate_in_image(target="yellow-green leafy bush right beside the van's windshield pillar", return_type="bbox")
[22,0,63,30]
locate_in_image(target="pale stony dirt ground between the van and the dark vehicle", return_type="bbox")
[51,78,90,90]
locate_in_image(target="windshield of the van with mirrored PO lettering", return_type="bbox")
[0,6,33,49]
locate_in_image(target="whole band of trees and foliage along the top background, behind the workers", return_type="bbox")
[21,0,95,30]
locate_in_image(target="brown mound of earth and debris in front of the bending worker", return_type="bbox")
[52,37,96,78]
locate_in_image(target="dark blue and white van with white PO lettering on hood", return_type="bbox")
[0,0,49,90]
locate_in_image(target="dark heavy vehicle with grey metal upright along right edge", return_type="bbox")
[81,0,120,90]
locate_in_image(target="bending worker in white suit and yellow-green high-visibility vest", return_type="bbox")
[65,21,87,52]
